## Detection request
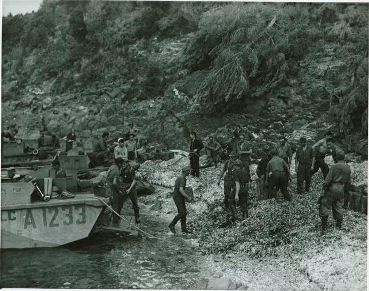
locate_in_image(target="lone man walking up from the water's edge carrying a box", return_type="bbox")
[169,167,191,233]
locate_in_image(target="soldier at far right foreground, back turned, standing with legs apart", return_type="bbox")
[319,150,351,234]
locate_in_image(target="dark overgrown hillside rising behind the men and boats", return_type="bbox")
[2,0,368,155]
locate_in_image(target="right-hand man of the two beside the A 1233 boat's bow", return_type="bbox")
[118,161,140,223]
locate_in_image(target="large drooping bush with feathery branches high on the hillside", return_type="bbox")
[186,3,310,111]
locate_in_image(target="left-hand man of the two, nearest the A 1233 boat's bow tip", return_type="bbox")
[106,158,123,226]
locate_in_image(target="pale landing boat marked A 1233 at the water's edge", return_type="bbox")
[1,180,106,249]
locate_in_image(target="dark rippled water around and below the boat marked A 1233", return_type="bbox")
[1,216,203,289]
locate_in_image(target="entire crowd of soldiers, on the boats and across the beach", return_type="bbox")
[3,117,351,233]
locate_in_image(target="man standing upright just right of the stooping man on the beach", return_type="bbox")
[295,137,314,194]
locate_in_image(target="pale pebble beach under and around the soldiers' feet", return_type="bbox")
[140,152,368,290]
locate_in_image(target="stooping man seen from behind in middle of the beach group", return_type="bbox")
[267,150,291,201]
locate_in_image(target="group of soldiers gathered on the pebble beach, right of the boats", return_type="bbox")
[169,131,351,234]
